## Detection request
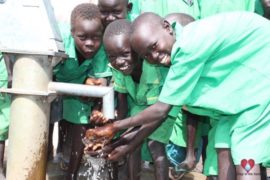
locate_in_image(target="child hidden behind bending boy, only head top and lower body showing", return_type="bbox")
[164,13,205,179]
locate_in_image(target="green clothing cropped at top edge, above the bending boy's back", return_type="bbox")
[198,0,255,18]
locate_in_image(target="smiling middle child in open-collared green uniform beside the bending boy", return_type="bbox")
[103,20,177,179]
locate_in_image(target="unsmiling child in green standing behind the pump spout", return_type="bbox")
[55,3,111,179]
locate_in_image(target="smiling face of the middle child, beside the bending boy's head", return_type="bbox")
[104,34,139,75]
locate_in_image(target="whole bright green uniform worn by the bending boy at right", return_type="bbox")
[159,12,270,165]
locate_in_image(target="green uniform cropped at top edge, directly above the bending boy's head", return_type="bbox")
[131,0,200,19]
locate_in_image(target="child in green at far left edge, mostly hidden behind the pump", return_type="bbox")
[0,53,10,179]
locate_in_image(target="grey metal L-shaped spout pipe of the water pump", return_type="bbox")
[48,82,114,119]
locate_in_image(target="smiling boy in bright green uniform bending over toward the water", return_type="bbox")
[88,12,270,179]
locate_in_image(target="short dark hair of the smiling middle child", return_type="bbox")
[103,19,131,41]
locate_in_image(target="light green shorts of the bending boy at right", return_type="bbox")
[231,102,270,166]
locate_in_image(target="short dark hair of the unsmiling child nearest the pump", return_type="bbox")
[70,3,101,28]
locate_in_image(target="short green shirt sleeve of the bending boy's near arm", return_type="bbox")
[159,25,220,106]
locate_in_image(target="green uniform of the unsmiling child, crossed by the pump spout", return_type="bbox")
[54,24,111,124]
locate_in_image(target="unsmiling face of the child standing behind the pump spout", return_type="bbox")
[72,18,103,59]
